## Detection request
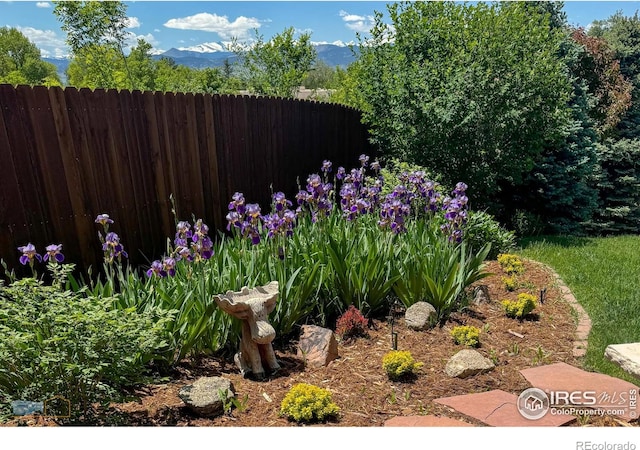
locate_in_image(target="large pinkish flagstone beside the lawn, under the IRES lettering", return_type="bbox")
[520,362,640,422]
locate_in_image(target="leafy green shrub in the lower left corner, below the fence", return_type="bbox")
[0,269,166,420]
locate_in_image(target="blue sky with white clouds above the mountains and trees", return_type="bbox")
[0,1,640,56]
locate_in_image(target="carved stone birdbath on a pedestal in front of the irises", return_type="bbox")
[213,281,280,380]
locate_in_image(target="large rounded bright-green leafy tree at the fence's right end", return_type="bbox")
[357,2,571,205]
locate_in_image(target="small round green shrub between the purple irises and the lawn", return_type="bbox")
[464,211,516,260]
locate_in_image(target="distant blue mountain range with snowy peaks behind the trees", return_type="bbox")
[43,43,358,78]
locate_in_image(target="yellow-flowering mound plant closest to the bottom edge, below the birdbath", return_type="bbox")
[280,383,340,422]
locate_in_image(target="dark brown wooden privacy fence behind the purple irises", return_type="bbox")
[0,85,372,269]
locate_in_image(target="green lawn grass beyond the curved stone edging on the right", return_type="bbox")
[519,236,640,385]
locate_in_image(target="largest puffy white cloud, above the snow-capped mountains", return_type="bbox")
[164,13,261,39]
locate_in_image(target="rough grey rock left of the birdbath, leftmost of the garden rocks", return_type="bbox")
[178,377,235,416]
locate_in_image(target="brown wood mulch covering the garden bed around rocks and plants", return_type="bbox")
[6,261,636,427]
